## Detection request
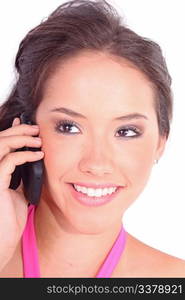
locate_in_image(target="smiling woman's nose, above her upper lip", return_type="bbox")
[79,141,114,176]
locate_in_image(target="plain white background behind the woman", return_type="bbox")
[0,0,185,259]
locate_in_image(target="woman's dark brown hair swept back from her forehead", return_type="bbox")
[0,0,173,138]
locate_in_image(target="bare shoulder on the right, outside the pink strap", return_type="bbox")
[112,233,185,278]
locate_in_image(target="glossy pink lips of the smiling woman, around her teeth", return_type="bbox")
[69,184,122,206]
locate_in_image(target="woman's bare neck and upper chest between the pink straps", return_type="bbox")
[35,201,122,277]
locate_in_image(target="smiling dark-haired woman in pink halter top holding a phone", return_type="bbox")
[0,0,185,277]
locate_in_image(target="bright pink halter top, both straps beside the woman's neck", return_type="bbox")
[22,204,126,278]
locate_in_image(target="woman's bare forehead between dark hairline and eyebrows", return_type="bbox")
[41,52,154,113]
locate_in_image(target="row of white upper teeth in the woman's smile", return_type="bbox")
[74,184,117,197]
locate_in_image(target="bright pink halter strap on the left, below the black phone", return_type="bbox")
[22,205,40,278]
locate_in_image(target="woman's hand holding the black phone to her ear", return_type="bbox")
[0,118,44,270]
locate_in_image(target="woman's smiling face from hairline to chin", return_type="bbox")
[36,52,166,233]
